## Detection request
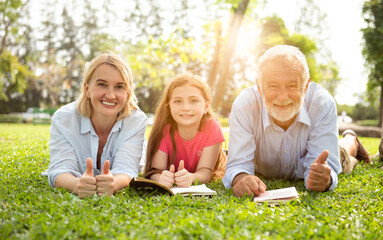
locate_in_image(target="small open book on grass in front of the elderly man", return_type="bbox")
[253,187,299,205]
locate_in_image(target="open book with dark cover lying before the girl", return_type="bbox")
[129,177,217,196]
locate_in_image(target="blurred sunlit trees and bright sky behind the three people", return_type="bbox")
[0,0,383,126]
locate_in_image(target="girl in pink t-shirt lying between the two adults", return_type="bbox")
[144,74,226,187]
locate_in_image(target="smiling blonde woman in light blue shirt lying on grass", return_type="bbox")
[48,53,146,198]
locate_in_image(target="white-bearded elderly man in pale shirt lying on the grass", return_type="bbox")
[223,45,368,197]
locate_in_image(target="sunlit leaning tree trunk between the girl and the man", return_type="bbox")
[213,0,249,111]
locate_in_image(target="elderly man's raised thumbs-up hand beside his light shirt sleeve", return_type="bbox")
[307,150,331,192]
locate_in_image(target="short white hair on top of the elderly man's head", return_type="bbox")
[257,45,310,85]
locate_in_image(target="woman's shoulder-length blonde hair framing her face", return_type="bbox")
[77,53,138,121]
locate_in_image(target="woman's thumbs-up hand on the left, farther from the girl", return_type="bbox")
[77,158,96,198]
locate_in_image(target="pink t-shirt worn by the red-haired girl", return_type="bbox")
[159,118,225,173]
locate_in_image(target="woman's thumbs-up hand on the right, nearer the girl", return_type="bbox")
[96,160,116,197]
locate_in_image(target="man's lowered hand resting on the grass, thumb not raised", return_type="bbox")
[233,173,266,197]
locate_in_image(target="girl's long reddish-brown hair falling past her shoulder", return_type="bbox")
[144,73,226,178]
